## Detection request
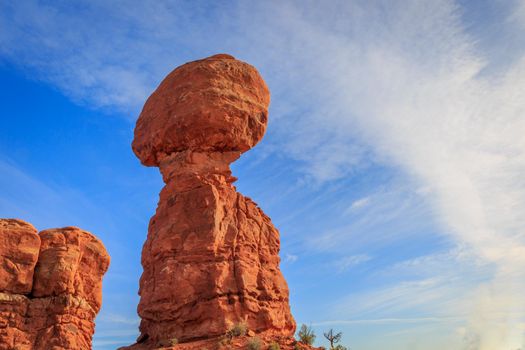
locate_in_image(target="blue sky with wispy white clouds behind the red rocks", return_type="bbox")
[0,0,525,350]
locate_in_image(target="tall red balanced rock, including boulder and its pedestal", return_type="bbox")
[127,54,295,349]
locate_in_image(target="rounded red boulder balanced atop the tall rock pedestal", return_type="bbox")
[132,54,270,166]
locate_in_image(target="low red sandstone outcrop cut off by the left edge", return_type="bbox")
[0,219,109,350]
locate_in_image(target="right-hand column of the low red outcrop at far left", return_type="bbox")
[28,227,109,350]
